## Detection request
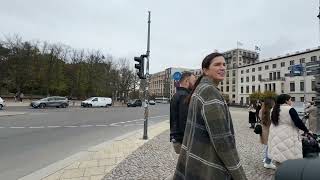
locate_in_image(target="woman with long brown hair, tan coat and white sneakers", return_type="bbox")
[259,99,276,169]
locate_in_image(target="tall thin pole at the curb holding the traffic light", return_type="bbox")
[142,11,151,139]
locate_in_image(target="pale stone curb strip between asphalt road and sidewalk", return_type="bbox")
[19,119,168,180]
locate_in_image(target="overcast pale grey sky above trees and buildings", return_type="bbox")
[0,0,319,73]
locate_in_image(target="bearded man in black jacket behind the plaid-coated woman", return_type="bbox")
[170,72,196,154]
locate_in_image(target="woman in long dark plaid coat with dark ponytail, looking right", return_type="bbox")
[173,53,247,180]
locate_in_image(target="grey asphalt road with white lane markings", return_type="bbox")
[0,104,169,180]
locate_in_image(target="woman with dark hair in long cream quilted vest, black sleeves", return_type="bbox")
[268,94,309,163]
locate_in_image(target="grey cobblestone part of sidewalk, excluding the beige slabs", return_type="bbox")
[104,111,275,180]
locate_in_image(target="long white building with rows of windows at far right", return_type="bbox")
[235,47,320,104]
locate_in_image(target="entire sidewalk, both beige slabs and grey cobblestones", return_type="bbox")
[23,109,274,180]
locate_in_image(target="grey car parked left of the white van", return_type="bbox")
[30,96,69,108]
